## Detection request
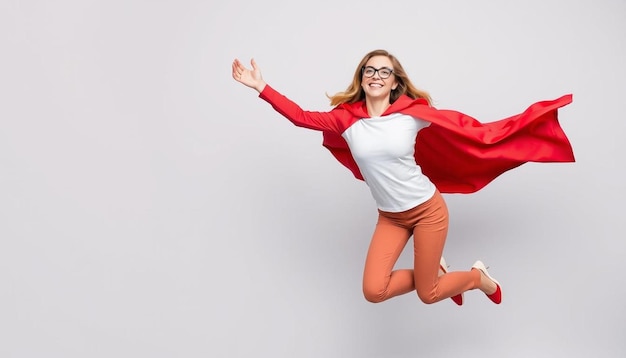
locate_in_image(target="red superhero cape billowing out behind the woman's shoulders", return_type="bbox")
[323,94,574,193]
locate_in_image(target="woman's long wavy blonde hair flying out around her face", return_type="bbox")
[326,50,432,106]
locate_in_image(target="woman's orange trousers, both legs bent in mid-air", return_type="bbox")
[363,191,480,303]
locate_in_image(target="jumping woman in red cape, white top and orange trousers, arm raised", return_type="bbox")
[232,50,573,305]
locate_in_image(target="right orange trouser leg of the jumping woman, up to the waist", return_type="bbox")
[413,192,480,303]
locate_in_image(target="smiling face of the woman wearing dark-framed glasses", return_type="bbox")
[361,56,398,101]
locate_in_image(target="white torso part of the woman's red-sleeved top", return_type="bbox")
[342,113,436,212]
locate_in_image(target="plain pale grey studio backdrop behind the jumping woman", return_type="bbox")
[0,0,626,358]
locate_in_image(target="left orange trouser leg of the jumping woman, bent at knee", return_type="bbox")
[363,215,415,303]
